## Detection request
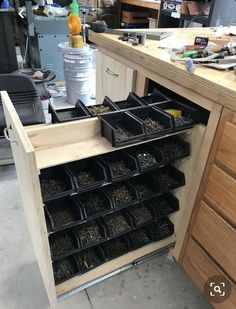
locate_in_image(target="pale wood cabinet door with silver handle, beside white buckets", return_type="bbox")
[96,51,135,104]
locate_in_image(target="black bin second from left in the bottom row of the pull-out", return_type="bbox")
[73,246,106,274]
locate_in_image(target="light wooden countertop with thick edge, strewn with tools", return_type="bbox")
[89,28,236,110]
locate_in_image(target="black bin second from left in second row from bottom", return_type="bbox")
[74,220,108,250]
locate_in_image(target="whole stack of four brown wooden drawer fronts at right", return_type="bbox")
[180,110,236,309]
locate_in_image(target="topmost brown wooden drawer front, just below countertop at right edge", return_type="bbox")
[216,121,236,172]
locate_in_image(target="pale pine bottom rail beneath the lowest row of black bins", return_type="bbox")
[56,235,175,296]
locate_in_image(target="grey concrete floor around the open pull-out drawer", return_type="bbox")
[0,166,212,309]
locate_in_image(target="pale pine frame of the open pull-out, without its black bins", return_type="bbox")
[2,87,212,308]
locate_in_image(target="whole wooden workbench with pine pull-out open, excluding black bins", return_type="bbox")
[2,29,236,309]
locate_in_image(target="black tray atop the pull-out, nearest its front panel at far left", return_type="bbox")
[48,101,91,123]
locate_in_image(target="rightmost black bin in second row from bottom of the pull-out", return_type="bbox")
[148,193,179,219]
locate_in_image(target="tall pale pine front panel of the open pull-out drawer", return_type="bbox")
[1,91,57,309]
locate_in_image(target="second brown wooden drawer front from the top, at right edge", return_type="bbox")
[204,165,236,227]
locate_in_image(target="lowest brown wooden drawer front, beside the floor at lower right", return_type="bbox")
[183,238,236,309]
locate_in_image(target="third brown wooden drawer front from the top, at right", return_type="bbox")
[192,202,236,282]
